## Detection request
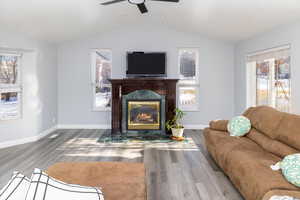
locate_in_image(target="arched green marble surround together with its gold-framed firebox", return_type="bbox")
[122,90,165,134]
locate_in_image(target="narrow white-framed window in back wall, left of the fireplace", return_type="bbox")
[92,49,112,111]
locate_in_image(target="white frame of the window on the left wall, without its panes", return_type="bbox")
[0,52,23,121]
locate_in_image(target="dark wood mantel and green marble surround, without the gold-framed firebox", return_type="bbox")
[109,78,178,135]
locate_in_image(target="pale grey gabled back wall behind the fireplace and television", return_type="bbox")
[58,24,234,126]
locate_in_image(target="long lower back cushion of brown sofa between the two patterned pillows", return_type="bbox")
[247,128,298,158]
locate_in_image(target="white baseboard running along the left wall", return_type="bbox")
[0,126,57,149]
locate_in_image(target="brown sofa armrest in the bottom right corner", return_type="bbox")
[262,189,300,200]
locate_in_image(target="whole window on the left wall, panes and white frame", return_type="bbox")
[0,54,22,120]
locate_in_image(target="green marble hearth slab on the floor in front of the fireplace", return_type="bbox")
[98,130,188,144]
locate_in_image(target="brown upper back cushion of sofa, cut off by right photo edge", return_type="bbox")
[276,113,300,150]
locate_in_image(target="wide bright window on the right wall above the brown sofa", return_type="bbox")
[247,46,291,112]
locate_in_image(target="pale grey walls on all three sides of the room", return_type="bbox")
[0,16,300,146]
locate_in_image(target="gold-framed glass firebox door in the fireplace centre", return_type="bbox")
[127,100,161,130]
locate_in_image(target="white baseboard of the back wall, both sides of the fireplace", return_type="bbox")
[57,124,208,129]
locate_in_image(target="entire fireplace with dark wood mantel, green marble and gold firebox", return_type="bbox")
[110,78,178,134]
